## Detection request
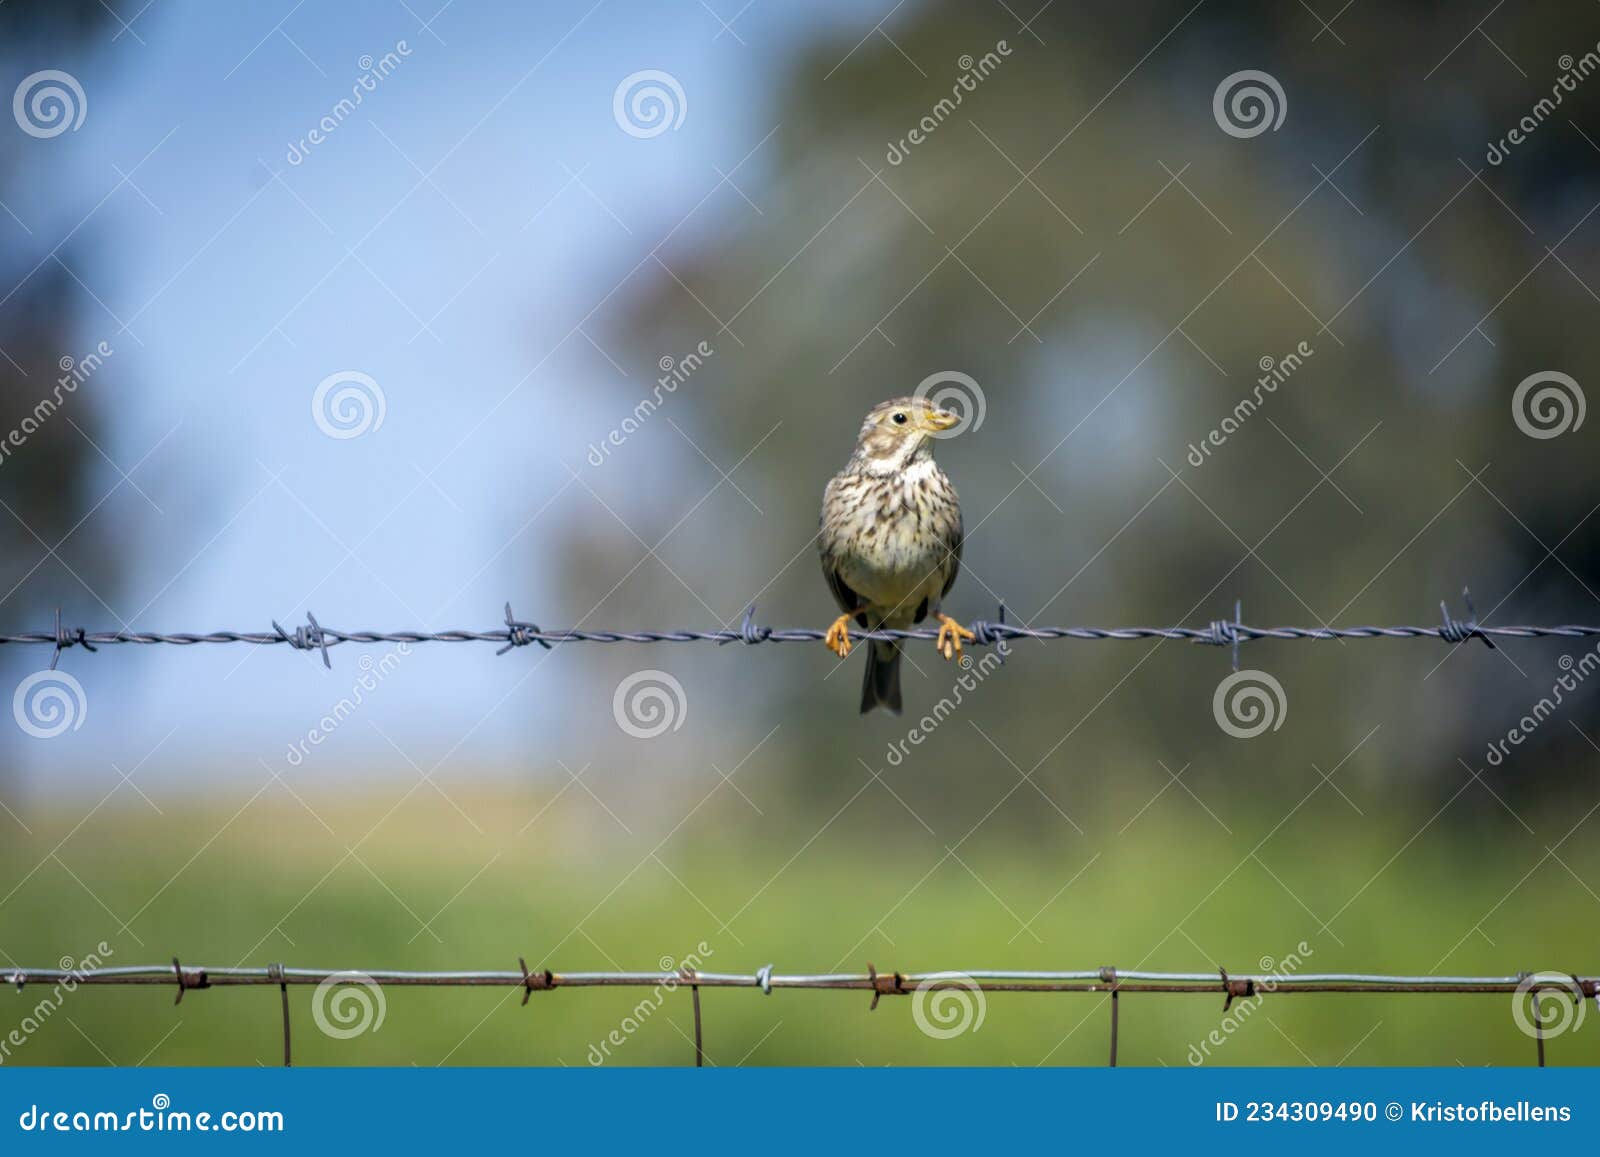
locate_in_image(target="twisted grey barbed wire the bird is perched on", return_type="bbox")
[0,591,1600,669]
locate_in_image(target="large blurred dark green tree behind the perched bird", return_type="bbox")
[592,2,1600,823]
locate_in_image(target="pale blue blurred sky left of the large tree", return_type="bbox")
[0,0,870,787]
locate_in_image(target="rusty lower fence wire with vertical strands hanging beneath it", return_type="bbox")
[0,957,1600,1069]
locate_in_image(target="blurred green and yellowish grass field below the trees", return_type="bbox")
[0,783,1600,1066]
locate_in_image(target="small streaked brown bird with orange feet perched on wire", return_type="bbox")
[818,397,974,715]
